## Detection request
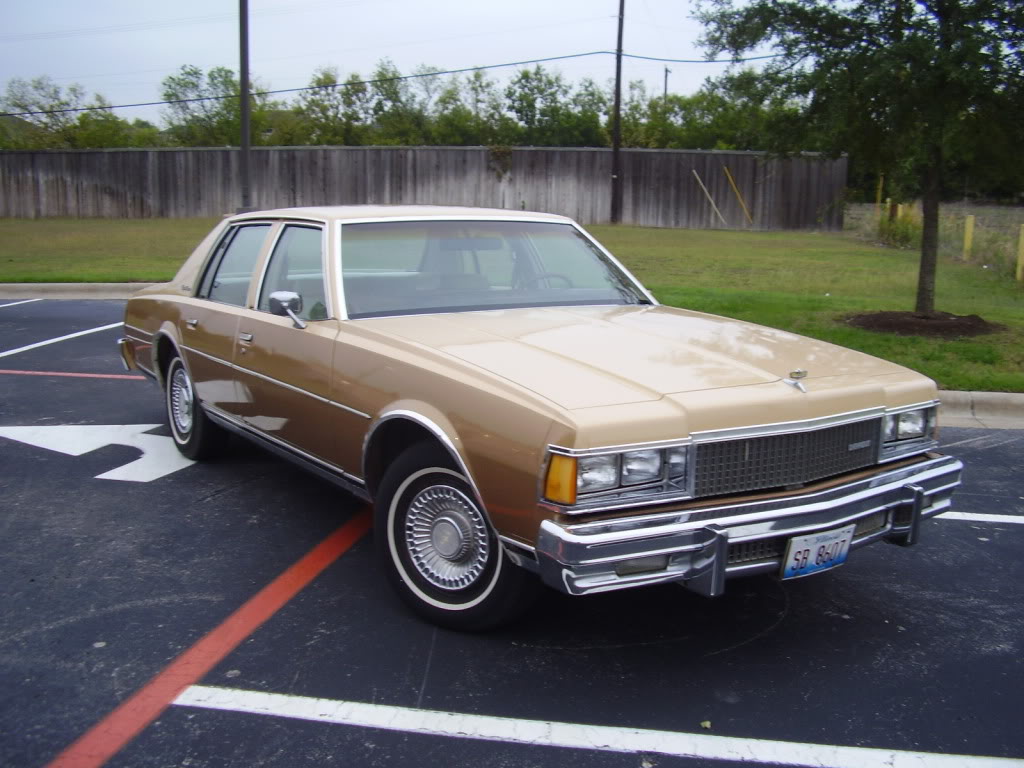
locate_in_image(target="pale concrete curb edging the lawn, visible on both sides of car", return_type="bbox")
[0,283,1024,429]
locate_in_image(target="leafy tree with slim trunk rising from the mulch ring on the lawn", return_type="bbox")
[697,0,1024,315]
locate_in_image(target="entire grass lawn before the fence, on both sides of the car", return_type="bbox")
[0,219,1024,392]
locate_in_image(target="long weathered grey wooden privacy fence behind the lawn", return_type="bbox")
[0,146,847,229]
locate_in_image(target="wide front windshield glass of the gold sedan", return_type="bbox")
[341,221,648,317]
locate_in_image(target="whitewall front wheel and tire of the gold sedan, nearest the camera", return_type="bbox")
[375,443,539,631]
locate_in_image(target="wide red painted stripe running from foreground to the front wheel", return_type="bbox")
[47,509,371,768]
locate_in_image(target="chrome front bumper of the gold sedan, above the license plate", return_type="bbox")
[537,454,964,597]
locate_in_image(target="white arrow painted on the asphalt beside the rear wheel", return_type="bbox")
[0,424,195,482]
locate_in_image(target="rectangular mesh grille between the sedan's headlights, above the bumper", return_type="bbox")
[694,419,882,497]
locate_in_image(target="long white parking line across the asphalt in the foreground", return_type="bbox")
[174,685,1022,768]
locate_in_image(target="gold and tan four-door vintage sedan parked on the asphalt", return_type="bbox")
[121,206,962,630]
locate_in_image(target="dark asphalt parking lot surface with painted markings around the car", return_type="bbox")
[6,300,1024,768]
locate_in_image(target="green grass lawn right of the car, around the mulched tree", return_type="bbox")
[589,226,1024,392]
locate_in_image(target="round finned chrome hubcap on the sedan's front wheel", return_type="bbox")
[406,485,490,590]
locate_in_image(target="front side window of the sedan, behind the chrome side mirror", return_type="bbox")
[256,224,327,321]
